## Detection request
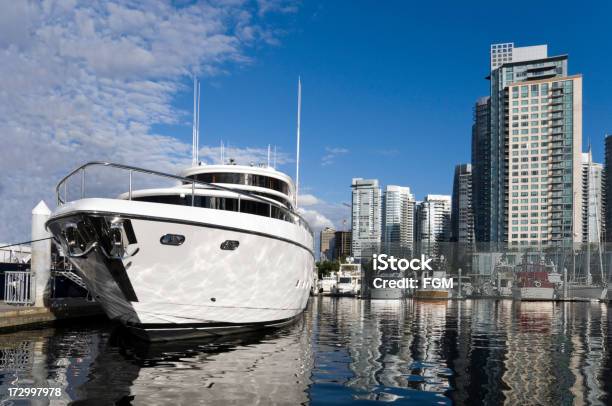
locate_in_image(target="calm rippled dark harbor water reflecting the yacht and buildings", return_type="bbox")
[0,297,612,405]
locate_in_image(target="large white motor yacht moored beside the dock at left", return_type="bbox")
[47,162,314,340]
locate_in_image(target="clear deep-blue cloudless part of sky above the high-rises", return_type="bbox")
[159,1,612,209]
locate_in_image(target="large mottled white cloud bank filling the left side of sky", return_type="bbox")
[0,0,298,241]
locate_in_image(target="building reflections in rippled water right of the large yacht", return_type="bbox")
[310,298,612,405]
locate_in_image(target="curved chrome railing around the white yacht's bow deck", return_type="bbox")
[55,161,313,235]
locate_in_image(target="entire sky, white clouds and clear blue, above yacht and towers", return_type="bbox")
[0,0,612,241]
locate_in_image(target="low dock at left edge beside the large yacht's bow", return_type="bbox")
[0,298,105,330]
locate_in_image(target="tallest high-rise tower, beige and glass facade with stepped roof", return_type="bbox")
[490,44,582,246]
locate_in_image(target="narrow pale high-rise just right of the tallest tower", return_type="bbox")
[581,152,604,243]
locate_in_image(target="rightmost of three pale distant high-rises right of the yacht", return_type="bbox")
[416,195,451,258]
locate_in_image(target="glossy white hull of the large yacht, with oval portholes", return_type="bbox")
[47,199,314,340]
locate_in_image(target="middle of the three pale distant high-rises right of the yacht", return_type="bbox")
[382,185,415,258]
